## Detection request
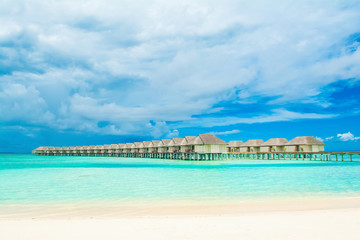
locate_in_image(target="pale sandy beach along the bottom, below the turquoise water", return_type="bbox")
[0,199,360,240]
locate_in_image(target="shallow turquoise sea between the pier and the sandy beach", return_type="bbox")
[0,154,360,203]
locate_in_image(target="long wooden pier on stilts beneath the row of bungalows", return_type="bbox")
[36,150,360,162]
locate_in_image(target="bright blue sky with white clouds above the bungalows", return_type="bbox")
[0,0,360,152]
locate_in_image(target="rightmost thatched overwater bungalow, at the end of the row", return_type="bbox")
[285,136,325,152]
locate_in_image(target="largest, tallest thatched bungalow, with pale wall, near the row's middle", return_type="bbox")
[188,134,226,153]
